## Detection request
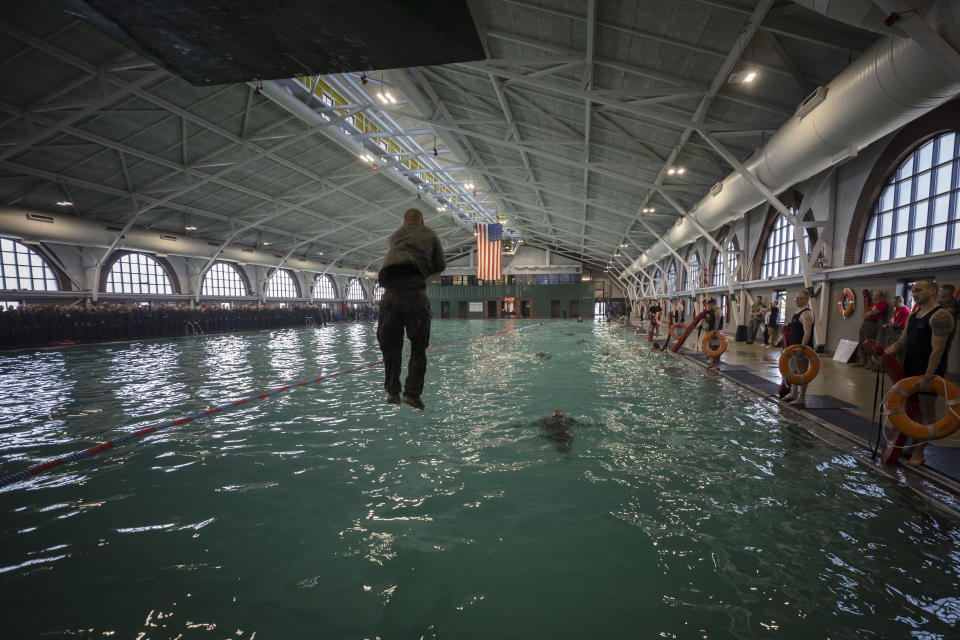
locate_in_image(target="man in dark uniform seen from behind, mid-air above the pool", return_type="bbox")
[377,209,447,409]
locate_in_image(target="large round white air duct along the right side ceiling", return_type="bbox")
[628,0,960,273]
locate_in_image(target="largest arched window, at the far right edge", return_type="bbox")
[860,131,960,262]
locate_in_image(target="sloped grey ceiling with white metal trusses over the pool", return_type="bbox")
[0,0,876,276]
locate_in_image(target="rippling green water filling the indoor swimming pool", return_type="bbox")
[0,320,960,640]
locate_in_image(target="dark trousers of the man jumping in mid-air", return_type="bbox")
[377,289,430,400]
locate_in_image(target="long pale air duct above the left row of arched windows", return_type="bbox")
[0,207,363,276]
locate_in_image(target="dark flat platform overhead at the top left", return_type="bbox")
[48,0,486,85]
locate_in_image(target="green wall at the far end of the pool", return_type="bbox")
[427,281,594,318]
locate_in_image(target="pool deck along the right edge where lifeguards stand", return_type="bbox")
[629,326,960,508]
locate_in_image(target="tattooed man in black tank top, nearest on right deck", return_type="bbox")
[874,280,956,467]
